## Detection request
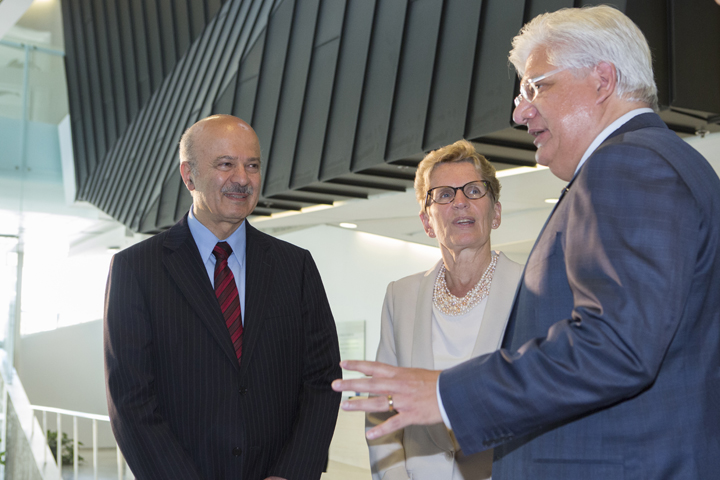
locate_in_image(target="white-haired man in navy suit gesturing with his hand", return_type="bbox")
[334,6,720,480]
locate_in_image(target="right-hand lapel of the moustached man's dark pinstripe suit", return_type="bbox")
[240,220,273,375]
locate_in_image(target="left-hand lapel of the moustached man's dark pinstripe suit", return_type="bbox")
[163,215,239,370]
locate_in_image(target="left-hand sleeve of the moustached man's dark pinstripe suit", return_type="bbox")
[104,255,201,480]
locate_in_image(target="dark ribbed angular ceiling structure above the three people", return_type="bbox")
[62,0,720,233]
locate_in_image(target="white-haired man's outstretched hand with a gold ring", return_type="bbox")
[332,360,442,440]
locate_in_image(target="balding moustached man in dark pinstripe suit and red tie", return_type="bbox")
[105,115,340,480]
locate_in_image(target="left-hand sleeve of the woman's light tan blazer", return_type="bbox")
[365,282,410,480]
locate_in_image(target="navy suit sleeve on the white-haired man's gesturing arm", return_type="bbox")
[440,143,701,453]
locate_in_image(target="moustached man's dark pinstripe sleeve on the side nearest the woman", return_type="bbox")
[269,251,342,480]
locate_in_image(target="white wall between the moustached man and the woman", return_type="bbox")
[278,220,440,360]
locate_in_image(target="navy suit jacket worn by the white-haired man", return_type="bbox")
[440,114,720,480]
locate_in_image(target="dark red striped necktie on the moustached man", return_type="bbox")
[213,242,243,363]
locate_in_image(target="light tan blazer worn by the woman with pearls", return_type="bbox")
[366,253,522,480]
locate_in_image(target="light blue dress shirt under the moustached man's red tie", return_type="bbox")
[188,207,247,326]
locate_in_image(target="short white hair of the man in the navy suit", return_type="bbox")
[509,5,658,110]
